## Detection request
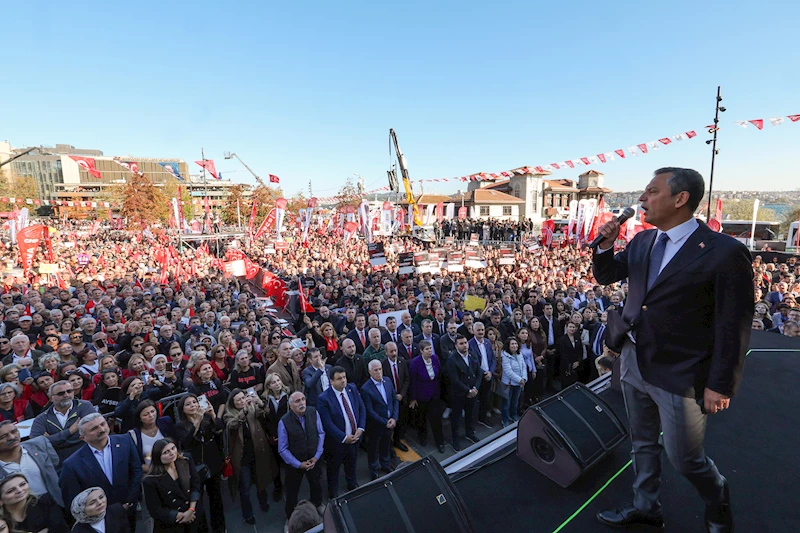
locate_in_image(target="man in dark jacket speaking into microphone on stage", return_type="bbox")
[593,168,754,533]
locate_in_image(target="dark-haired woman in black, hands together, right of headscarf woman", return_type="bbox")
[142,439,202,533]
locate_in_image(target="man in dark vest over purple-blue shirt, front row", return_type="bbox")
[278,391,325,520]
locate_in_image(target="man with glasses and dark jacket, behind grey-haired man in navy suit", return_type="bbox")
[31,380,95,462]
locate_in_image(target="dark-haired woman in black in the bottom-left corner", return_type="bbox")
[0,472,69,533]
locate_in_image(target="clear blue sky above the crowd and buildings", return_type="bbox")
[0,0,800,196]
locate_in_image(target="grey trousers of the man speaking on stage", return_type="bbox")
[621,340,728,515]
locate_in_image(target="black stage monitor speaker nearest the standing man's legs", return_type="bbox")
[517,383,628,487]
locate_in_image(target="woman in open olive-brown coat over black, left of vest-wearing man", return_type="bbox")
[225,389,277,524]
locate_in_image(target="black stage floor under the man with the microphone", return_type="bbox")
[455,332,800,533]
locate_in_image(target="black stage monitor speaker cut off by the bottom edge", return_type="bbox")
[323,457,475,533]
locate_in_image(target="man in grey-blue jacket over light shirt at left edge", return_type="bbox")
[0,420,64,507]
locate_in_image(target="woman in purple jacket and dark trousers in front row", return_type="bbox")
[408,339,444,453]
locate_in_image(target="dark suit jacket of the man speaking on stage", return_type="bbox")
[593,222,754,398]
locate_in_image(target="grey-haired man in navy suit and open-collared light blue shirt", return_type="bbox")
[59,413,142,531]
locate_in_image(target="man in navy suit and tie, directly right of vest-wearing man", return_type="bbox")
[317,366,367,499]
